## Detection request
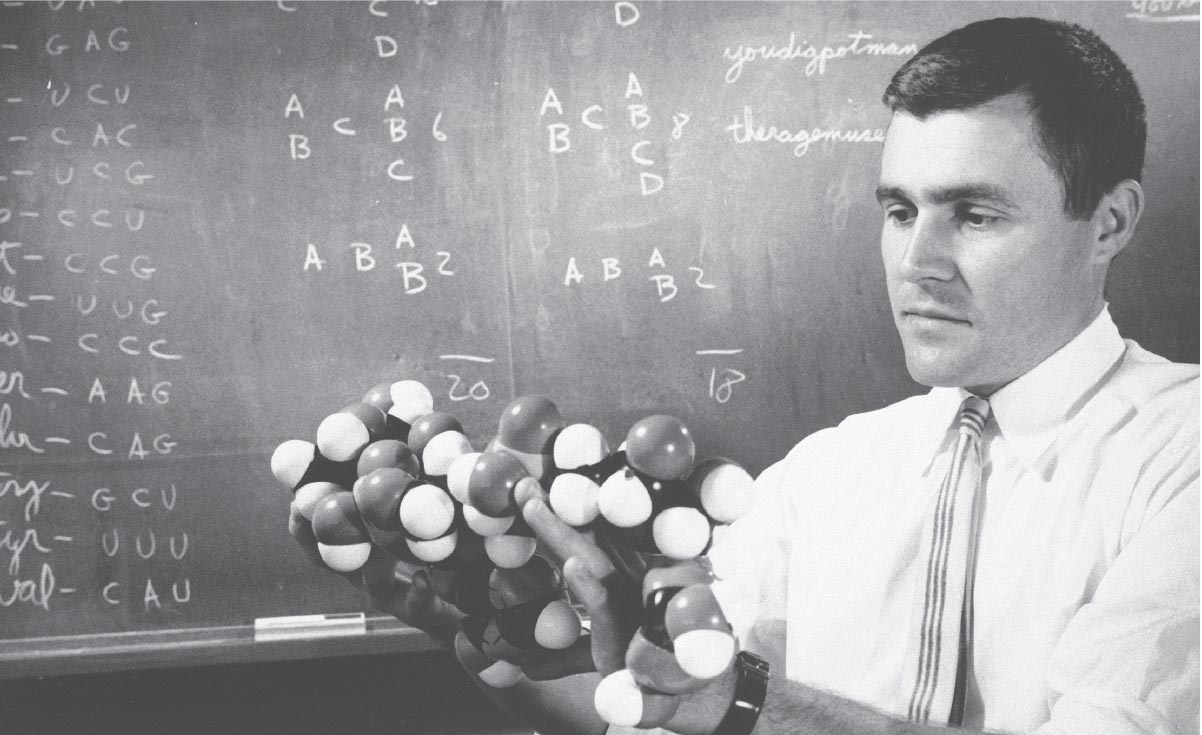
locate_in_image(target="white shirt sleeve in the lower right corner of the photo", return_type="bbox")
[1036,435,1198,735]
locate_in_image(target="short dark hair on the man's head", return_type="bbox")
[883,18,1148,219]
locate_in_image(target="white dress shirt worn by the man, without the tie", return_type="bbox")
[710,309,1198,735]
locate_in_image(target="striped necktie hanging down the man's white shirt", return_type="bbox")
[900,396,989,724]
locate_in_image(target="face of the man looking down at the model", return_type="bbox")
[877,95,1102,395]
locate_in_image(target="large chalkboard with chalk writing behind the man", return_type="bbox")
[0,0,1198,677]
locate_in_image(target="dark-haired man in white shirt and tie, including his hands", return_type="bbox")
[288,14,1198,735]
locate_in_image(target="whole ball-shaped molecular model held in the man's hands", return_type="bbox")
[272,380,752,725]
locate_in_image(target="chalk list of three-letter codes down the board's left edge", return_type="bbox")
[13,15,191,625]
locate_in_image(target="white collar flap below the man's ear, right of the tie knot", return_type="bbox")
[976,306,1126,474]
